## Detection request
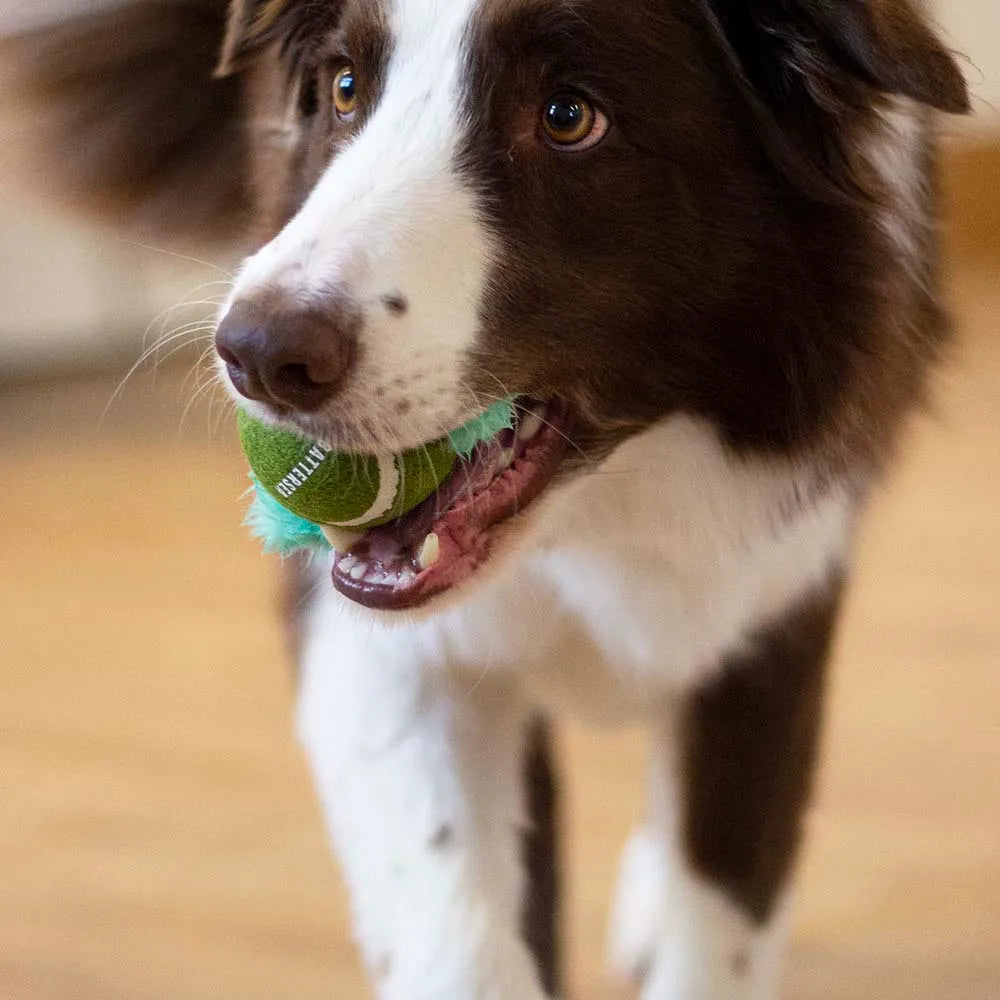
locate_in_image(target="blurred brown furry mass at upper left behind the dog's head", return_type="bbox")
[0,0,248,245]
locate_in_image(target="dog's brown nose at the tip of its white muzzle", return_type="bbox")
[215,301,360,412]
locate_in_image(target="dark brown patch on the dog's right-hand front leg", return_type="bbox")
[683,583,841,923]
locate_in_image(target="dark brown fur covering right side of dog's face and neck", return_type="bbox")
[458,3,964,477]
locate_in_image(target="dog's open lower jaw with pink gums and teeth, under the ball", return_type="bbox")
[333,397,571,611]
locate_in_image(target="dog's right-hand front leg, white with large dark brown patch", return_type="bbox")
[613,587,839,1000]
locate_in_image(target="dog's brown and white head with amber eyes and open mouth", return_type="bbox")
[1,0,967,606]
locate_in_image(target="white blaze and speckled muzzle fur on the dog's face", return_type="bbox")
[223,0,493,451]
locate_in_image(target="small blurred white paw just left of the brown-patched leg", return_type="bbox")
[608,827,667,985]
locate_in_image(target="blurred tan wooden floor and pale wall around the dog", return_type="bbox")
[0,0,1000,1000]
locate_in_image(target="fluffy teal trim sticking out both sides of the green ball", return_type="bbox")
[243,398,514,556]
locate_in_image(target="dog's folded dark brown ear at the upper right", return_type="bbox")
[708,0,970,114]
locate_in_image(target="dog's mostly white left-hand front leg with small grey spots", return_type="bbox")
[292,592,560,1000]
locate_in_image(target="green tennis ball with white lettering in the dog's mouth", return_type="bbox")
[237,410,456,529]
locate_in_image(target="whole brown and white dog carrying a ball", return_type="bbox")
[5,0,968,1000]
